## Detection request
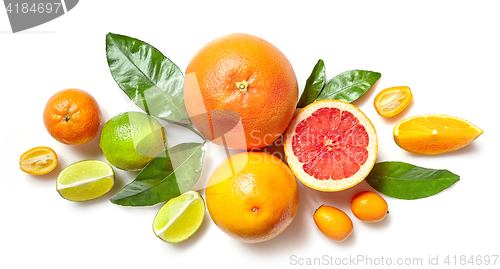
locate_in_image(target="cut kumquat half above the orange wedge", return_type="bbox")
[373,86,413,118]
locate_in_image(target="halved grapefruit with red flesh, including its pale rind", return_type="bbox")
[284,100,378,191]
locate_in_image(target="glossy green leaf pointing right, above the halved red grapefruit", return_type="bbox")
[315,70,382,103]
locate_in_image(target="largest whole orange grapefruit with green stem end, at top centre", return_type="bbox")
[184,34,298,149]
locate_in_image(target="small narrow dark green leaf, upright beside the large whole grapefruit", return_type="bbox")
[297,59,326,108]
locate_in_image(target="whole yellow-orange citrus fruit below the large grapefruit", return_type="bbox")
[205,152,299,243]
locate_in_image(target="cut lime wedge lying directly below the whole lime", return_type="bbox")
[56,160,115,202]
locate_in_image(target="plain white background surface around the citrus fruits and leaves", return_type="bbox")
[0,0,500,268]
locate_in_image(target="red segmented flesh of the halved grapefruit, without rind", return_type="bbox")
[292,107,369,180]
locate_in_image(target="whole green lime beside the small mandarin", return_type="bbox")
[99,112,167,171]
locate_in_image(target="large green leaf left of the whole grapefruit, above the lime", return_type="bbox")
[106,33,191,125]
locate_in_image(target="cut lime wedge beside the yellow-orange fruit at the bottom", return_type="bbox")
[153,191,205,243]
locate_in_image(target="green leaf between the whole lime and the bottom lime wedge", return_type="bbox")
[111,143,205,206]
